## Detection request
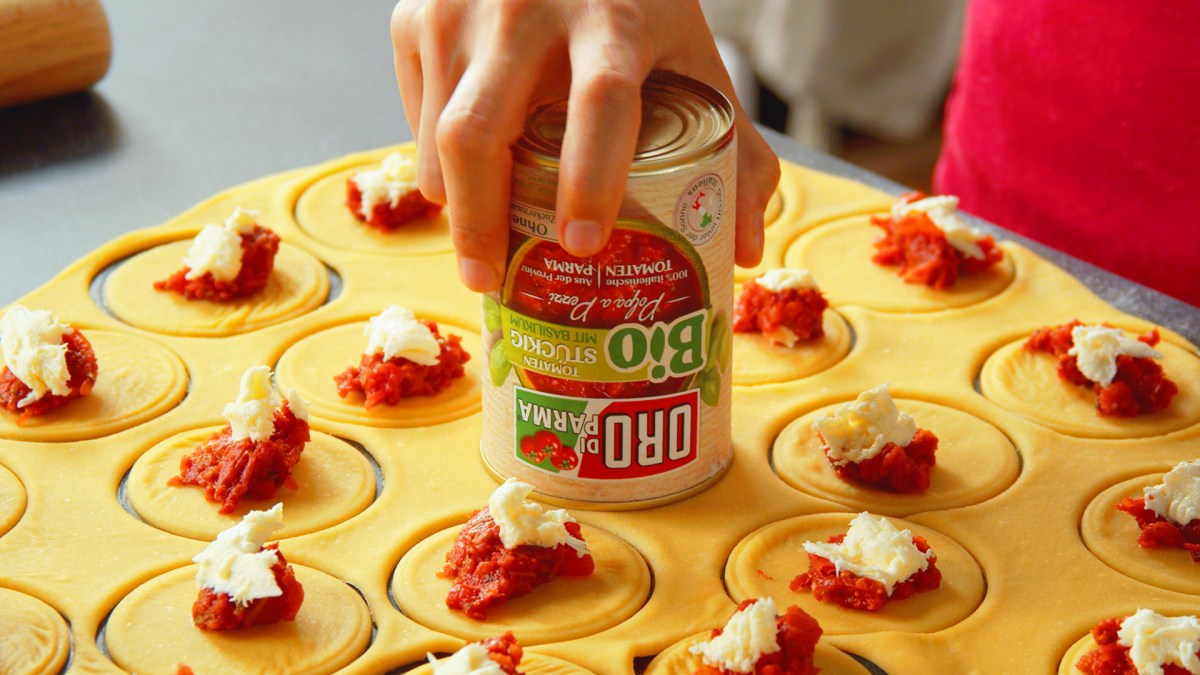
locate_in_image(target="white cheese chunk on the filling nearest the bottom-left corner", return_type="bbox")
[192,503,283,605]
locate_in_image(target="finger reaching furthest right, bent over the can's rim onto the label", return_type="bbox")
[558,2,654,256]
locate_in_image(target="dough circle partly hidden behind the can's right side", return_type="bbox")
[733,309,851,386]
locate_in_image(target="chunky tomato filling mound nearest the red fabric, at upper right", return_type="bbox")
[871,192,1004,289]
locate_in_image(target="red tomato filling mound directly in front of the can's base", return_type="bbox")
[439,507,595,621]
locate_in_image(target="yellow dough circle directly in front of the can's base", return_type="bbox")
[391,525,650,646]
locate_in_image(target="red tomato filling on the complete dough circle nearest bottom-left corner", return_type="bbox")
[192,542,304,631]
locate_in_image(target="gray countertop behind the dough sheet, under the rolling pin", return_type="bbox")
[0,0,1200,344]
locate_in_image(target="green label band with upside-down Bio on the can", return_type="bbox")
[493,306,709,382]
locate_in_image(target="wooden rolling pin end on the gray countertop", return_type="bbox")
[0,0,113,107]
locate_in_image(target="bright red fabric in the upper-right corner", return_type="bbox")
[934,0,1200,306]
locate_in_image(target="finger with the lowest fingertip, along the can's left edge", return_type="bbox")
[436,5,553,292]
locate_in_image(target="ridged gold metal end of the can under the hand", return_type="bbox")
[514,71,733,174]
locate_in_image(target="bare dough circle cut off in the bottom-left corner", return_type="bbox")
[0,589,71,675]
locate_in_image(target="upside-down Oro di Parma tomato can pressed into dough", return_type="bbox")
[481,72,737,509]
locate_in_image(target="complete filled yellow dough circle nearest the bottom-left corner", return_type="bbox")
[106,562,371,675]
